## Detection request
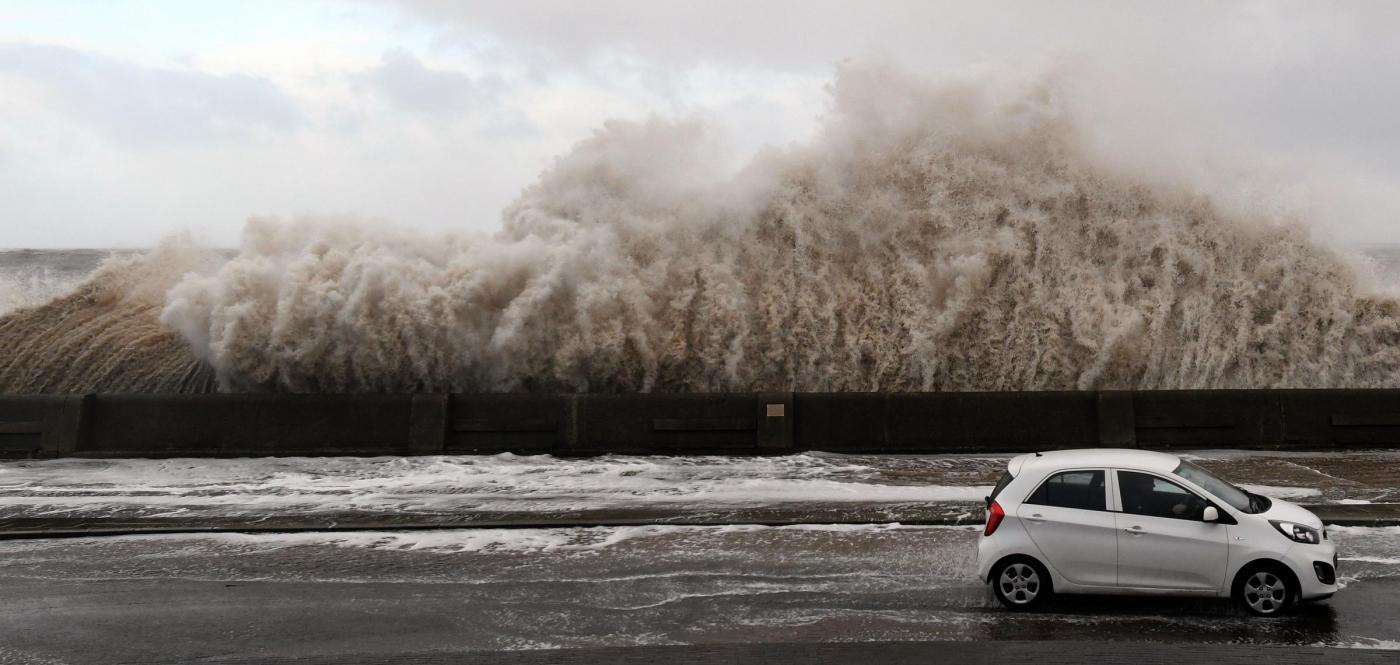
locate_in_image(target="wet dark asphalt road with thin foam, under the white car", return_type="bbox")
[0,526,1400,664]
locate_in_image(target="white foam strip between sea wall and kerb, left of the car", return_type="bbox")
[0,454,990,515]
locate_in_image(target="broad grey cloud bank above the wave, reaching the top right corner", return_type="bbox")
[372,0,1400,169]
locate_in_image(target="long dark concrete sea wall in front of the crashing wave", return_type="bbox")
[0,391,1400,458]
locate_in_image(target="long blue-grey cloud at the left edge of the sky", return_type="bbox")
[0,43,302,144]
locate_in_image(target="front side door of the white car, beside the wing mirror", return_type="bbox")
[1116,469,1229,591]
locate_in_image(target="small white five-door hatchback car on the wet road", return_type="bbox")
[977,449,1337,616]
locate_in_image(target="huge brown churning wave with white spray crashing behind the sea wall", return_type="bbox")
[0,70,1400,392]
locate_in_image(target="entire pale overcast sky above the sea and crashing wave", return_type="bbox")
[0,0,1400,246]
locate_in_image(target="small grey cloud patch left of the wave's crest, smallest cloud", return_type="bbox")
[354,49,503,113]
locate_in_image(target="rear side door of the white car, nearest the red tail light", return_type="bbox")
[1016,469,1119,587]
